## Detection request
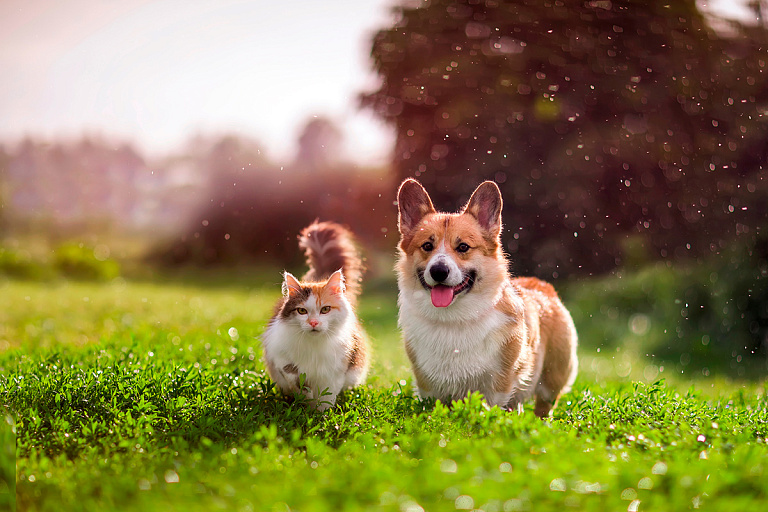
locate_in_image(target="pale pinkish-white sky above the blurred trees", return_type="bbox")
[0,0,756,164]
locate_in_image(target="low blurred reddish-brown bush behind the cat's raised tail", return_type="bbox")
[153,168,397,267]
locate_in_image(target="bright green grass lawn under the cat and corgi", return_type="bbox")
[0,273,768,512]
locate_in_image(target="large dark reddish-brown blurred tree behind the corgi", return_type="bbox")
[362,0,768,277]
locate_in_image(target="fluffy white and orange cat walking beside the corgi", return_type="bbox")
[262,221,370,411]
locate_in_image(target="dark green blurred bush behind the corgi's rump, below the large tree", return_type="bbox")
[565,239,768,376]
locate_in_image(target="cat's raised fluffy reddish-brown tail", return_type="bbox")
[299,220,364,302]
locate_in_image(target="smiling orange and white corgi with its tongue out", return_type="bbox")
[396,179,578,417]
